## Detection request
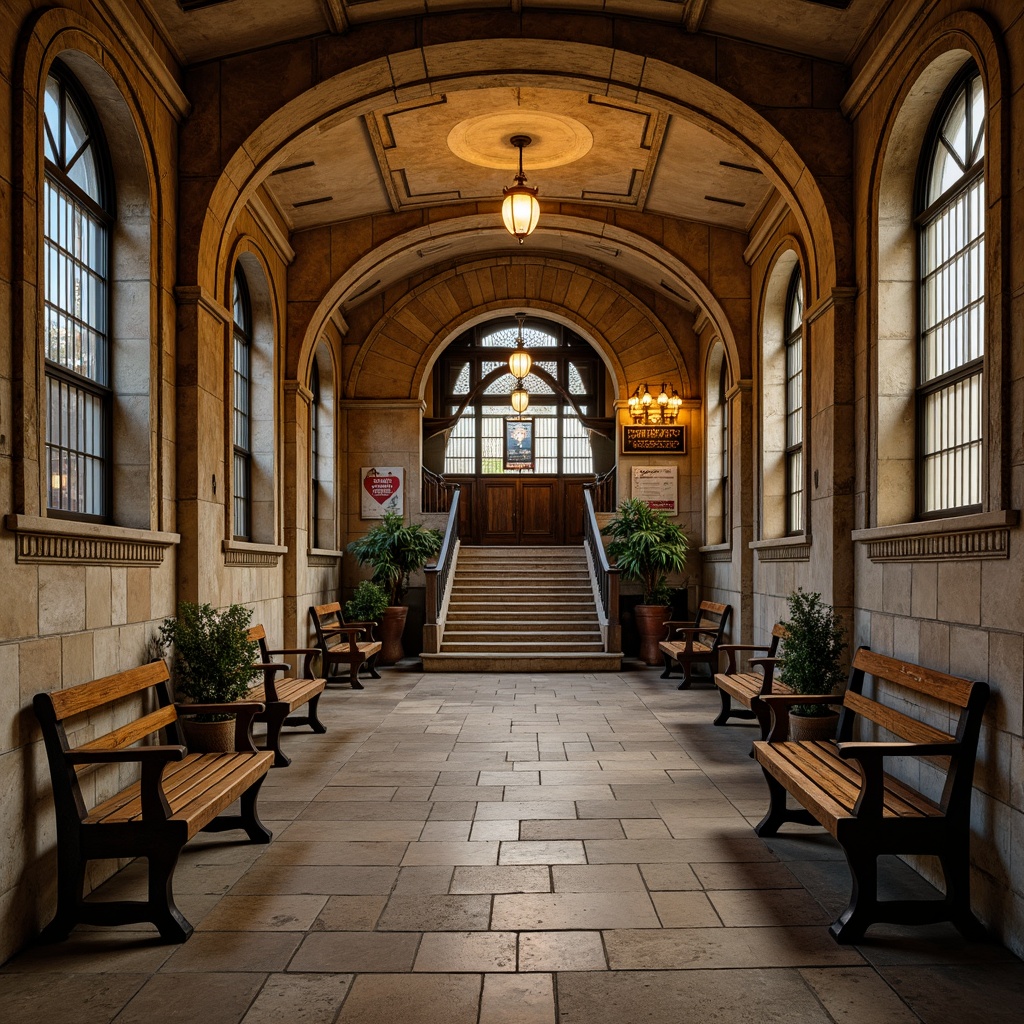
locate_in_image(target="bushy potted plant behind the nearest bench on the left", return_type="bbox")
[159,601,262,751]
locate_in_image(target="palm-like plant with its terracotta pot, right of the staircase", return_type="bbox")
[601,498,689,665]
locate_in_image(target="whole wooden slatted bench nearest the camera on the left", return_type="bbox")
[33,662,273,942]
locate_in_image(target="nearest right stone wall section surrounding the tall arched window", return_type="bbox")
[837,0,1024,953]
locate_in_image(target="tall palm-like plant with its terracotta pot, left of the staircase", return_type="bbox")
[348,512,441,665]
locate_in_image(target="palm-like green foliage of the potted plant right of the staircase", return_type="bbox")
[601,498,689,605]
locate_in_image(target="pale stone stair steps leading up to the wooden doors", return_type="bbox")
[422,546,622,672]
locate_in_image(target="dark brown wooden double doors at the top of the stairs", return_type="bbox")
[449,475,593,546]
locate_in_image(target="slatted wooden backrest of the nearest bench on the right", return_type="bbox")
[837,647,988,812]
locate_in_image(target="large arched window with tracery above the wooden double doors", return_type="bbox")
[434,318,604,476]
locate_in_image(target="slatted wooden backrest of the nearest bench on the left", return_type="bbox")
[32,660,184,820]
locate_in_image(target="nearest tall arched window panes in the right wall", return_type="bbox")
[916,62,985,518]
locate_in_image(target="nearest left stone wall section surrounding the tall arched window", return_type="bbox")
[0,0,187,962]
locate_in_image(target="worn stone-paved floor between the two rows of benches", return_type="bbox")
[0,667,1024,1024]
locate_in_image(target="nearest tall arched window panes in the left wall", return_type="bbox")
[43,63,114,520]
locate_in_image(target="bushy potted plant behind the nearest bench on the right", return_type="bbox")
[778,588,847,739]
